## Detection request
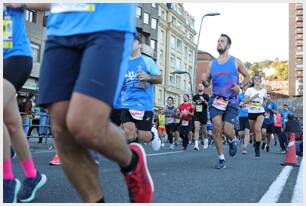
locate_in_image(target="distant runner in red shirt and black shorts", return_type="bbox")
[179,94,194,150]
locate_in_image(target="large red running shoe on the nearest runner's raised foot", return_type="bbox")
[124,143,154,203]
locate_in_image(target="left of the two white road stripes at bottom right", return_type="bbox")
[259,166,292,203]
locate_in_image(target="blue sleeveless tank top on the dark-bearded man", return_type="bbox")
[210,56,239,97]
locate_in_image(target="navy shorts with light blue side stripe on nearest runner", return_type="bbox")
[39,31,134,107]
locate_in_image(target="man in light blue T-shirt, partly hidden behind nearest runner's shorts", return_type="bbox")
[121,37,162,151]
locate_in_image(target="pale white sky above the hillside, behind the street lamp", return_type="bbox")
[184,3,289,62]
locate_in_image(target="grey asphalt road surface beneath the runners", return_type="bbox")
[13,141,303,203]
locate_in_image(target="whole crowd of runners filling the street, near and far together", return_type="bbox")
[3,3,301,202]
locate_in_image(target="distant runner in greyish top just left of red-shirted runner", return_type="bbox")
[164,96,176,150]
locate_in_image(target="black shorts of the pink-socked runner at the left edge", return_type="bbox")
[3,56,33,91]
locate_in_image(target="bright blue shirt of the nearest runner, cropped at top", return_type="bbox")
[47,3,136,36]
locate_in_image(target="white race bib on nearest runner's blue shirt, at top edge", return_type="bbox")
[51,3,96,13]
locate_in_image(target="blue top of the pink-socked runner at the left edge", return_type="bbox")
[3,7,32,59]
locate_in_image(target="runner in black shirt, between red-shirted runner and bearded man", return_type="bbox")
[193,84,209,150]
